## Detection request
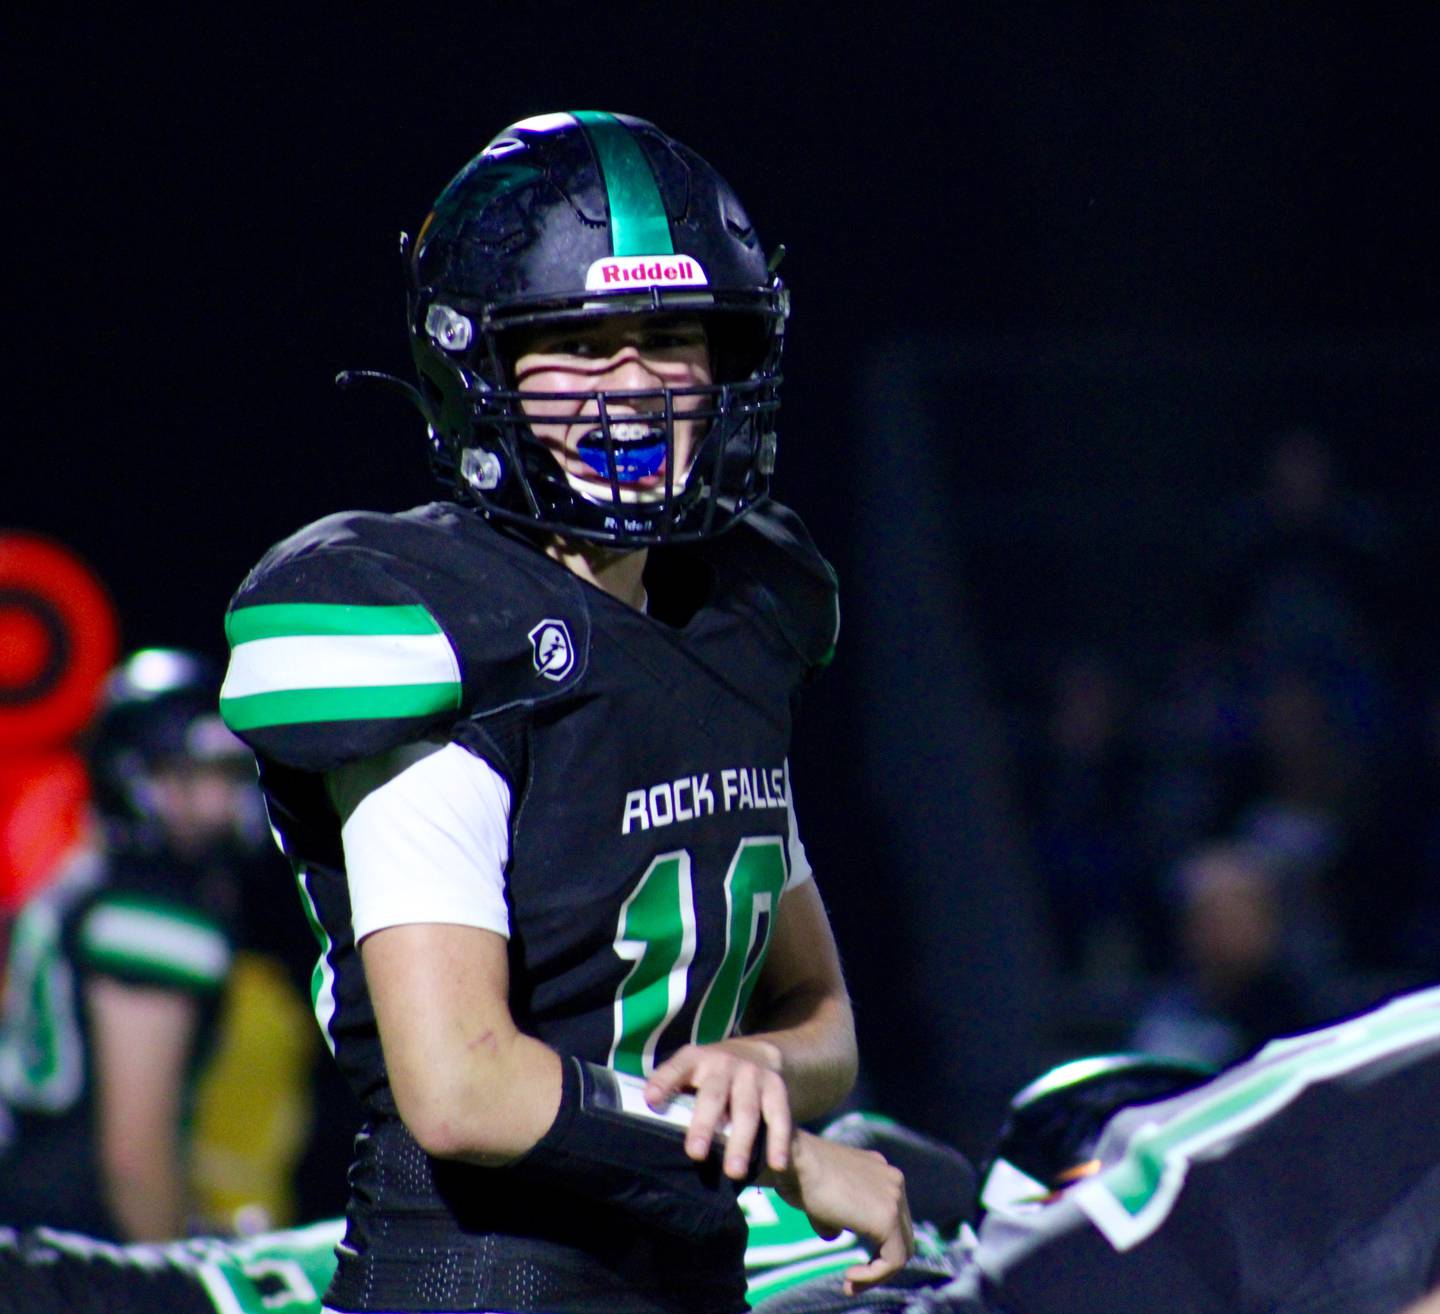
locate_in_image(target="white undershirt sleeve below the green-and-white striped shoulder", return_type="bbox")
[333,743,510,944]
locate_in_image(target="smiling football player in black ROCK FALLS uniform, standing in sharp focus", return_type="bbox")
[222,111,912,1314]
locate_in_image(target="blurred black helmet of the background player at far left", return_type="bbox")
[89,648,251,840]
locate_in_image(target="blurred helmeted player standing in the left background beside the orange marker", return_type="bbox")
[0,648,256,1241]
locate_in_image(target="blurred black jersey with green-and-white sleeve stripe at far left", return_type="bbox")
[0,846,245,1238]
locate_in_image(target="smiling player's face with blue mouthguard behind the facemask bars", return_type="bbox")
[516,316,711,503]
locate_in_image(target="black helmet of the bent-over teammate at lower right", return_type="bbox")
[981,1053,1215,1209]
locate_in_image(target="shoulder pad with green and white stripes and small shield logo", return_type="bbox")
[220,503,589,771]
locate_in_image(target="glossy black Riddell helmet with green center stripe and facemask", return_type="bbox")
[406,111,789,548]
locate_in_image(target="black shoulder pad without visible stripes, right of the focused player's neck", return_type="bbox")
[704,501,840,669]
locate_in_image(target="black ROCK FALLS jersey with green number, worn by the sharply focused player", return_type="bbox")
[222,504,838,1310]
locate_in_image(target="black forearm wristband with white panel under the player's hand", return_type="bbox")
[507,1056,744,1241]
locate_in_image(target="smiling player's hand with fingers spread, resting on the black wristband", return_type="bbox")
[645,1036,793,1181]
